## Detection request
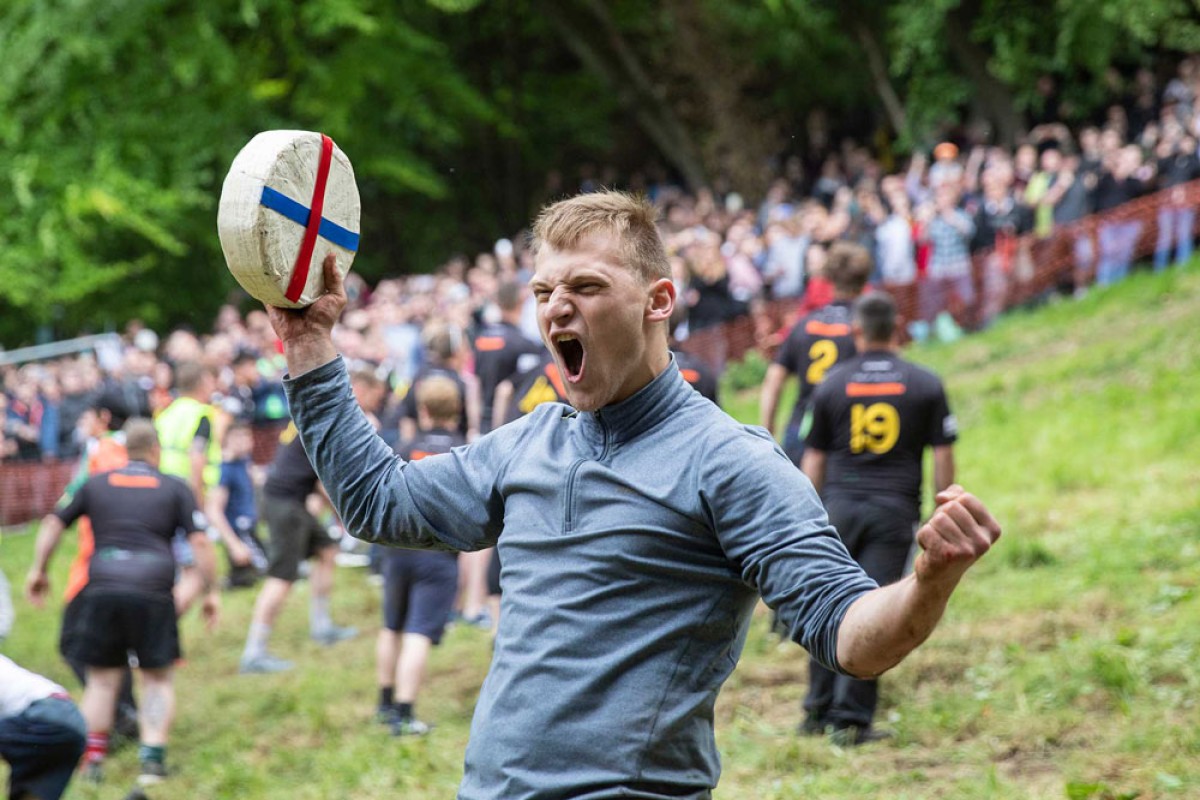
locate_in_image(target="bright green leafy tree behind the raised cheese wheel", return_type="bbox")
[0,0,493,343]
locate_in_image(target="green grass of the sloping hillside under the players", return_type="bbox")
[0,266,1200,800]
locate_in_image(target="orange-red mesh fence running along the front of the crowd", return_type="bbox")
[0,181,1200,527]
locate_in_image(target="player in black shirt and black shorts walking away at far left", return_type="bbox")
[26,419,218,784]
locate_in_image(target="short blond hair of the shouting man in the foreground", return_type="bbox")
[533,191,671,283]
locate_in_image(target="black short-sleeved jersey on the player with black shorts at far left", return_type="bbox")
[54,461,208,596]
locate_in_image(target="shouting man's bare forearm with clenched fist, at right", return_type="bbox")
[838,486,1001,678]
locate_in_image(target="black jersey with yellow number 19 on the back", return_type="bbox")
[808,350,958,521]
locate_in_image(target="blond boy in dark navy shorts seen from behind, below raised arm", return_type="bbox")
[376,377,466,736]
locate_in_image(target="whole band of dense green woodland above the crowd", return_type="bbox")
[0,0,1200,348]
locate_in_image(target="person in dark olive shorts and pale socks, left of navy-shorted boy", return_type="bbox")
[239,371,385,673]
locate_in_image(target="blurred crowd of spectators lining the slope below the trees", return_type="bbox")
[0,56,1200,461]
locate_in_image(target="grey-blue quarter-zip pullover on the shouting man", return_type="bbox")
[286,359,875,800]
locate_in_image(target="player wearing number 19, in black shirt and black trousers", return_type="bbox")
[800,293,958,744]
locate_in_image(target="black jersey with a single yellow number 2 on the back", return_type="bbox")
[775,300,854,426]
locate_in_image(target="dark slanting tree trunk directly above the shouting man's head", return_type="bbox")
[539,0,707,191]
